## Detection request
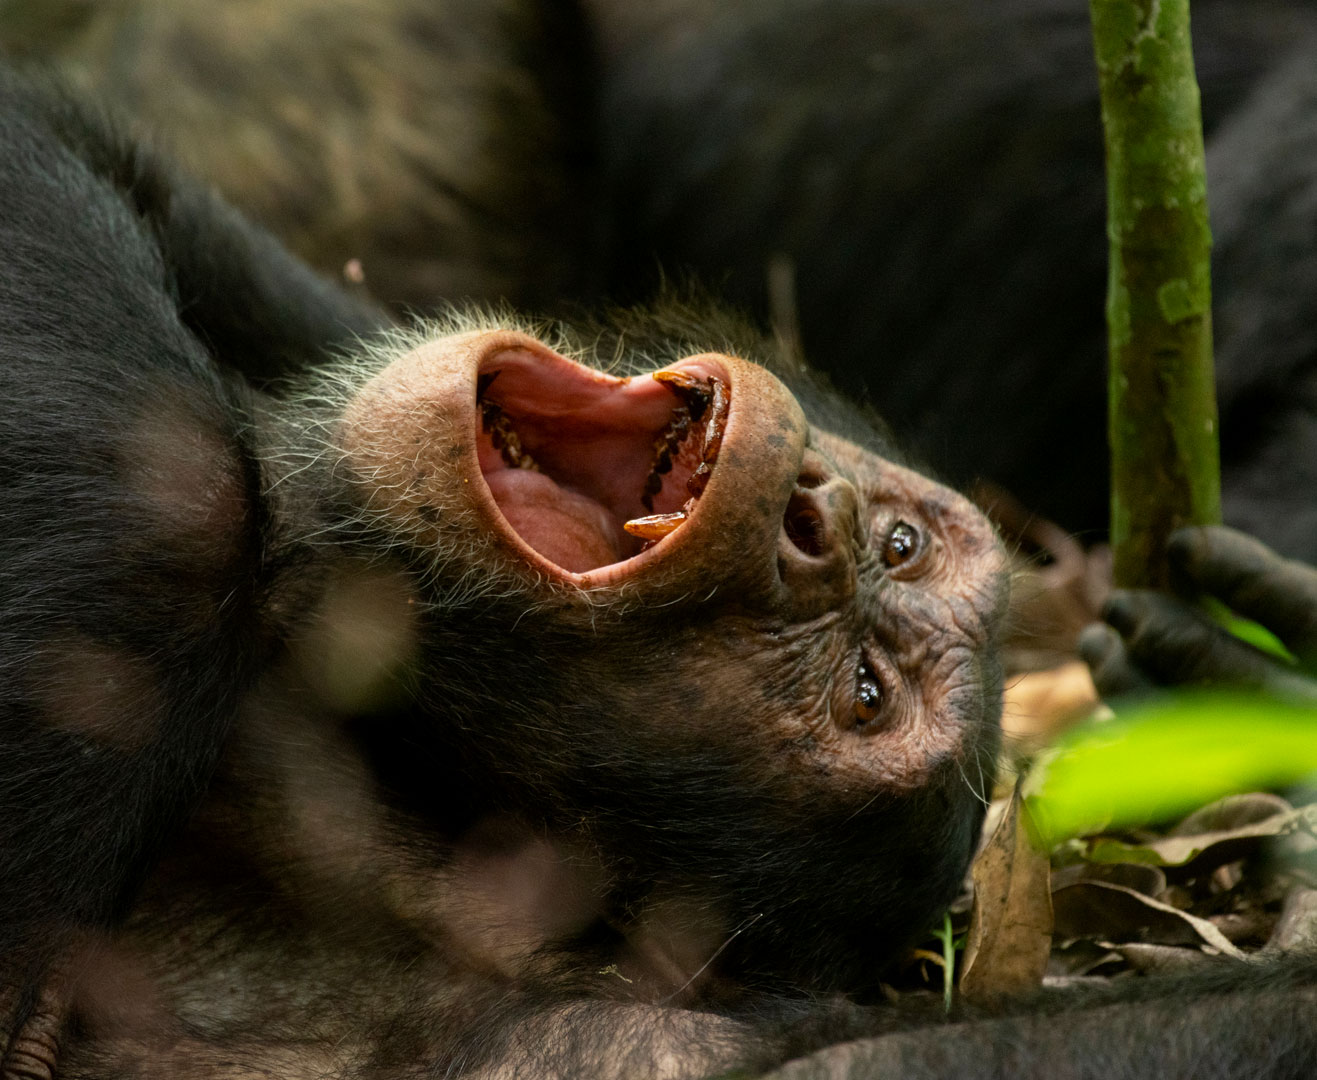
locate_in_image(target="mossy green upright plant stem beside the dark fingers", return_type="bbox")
[1089,0,1221,587]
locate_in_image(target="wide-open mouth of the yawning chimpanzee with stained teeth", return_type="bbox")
[475,349,731,573]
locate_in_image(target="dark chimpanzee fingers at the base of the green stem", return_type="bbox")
[1080,527,1317,701]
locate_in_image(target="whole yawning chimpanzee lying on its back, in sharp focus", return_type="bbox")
[0,33,1317,1080]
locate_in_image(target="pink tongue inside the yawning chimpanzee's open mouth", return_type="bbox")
[485,469,623,574]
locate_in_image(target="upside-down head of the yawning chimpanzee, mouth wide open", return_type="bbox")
[323,322,1005,981]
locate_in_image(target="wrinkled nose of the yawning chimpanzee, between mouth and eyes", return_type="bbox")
[777,452,863,619]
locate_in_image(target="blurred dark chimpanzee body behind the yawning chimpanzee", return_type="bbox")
[0,0,1317,560]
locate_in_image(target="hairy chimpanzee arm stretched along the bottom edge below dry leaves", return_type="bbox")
[405,960,1317,1080]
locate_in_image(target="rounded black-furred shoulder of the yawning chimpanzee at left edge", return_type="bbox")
[0,63,259,955]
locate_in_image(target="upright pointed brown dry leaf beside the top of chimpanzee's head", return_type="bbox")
[960,785,1052,1001]
